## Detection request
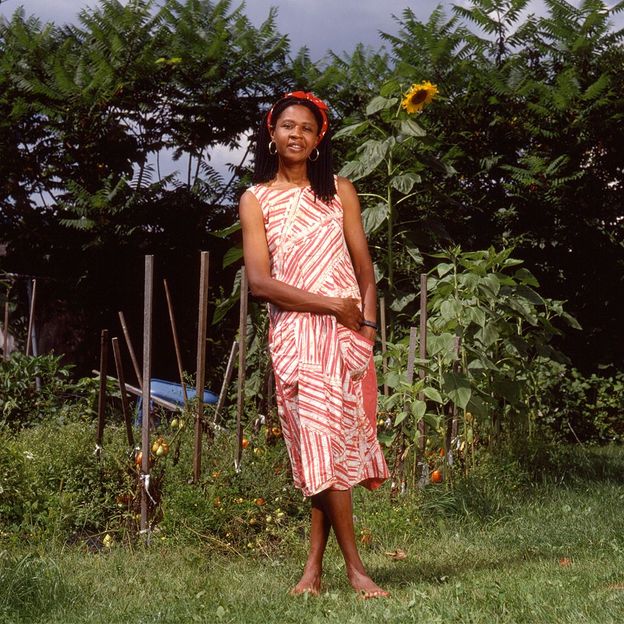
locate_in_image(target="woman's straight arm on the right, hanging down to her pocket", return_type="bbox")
[338,178,377,340]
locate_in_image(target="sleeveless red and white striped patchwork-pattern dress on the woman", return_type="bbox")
[249,185,388,496]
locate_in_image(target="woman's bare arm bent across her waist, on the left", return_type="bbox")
[239,192,362,330]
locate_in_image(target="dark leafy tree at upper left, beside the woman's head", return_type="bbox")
[0,0,288,372]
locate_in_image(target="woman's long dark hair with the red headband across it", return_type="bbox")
[252,97,336,202]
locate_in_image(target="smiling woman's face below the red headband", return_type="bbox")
[271,104,319,162]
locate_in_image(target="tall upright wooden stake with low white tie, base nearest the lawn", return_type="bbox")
[139,256,154,533]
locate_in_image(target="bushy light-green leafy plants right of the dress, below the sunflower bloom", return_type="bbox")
[381,248,578,480]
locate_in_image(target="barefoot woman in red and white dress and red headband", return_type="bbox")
[240,91,388,598]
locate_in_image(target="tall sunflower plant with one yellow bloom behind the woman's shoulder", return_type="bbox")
[334,79,454,313]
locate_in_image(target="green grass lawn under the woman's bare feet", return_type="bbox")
[0,449,624,624]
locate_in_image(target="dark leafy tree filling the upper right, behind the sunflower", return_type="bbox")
[380,0,624,370]
